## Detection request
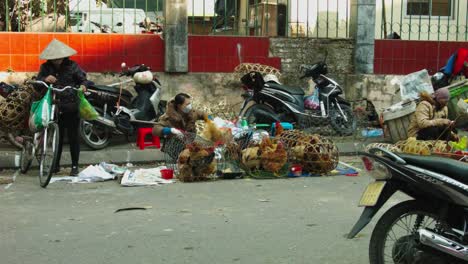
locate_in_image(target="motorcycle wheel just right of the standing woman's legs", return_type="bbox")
[80,120,110,150]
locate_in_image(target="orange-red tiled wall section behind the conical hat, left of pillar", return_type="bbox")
[0,33,164,72]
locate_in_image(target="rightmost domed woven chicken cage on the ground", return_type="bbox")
[279,130,339,174]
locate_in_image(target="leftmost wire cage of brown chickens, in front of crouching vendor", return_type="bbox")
[162,133,217,182]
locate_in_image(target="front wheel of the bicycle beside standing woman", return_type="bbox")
[39,123,59,188]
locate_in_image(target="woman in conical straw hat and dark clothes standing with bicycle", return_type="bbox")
[37,39,88,176]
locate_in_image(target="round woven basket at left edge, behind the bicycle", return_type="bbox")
[0,86,37,131]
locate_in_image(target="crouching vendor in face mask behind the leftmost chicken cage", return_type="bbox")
[153,93,209,138]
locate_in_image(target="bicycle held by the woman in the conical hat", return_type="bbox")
[20,81,78,188]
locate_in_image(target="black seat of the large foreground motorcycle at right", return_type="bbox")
[398,154,468,183]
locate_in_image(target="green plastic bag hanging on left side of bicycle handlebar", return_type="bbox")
[29,89,52,132]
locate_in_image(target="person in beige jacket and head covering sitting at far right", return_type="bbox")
[408,88,458,141]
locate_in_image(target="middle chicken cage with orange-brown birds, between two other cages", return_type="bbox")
[240,137,288,177]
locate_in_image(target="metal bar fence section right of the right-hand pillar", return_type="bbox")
[376,0,468,41]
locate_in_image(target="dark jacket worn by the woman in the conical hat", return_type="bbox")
[37,58,87,113]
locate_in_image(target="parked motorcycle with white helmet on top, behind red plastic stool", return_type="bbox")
[80,63,167,149]
